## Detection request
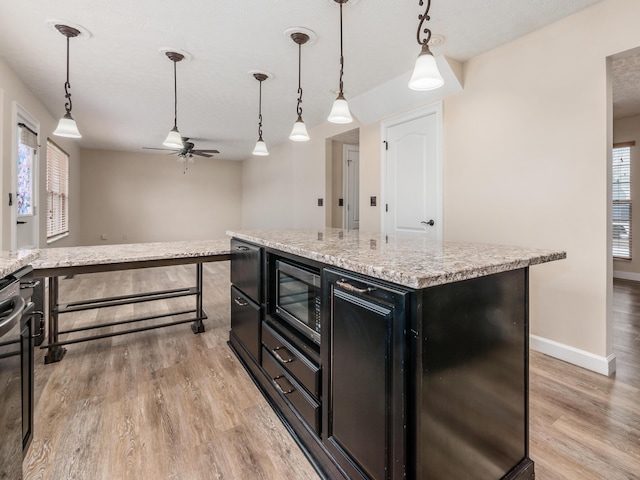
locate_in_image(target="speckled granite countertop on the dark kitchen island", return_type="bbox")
[227,228,566,289]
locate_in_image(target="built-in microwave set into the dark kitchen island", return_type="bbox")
[275,260,321,345]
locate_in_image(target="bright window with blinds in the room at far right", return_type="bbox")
[611,143,634,260]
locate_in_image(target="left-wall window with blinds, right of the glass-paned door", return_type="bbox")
[47,139,69,240]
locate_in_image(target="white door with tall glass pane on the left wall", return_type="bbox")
[11,105,39,250]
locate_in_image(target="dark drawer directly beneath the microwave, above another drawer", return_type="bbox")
[262,324,320,399]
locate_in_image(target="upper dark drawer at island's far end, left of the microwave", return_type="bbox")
[231,238,262,303]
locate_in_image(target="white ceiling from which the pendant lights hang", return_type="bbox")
[0,0,600,160]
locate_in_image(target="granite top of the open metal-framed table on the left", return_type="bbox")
[32,238,229,269]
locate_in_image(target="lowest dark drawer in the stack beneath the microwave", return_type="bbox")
[262,347,320,435]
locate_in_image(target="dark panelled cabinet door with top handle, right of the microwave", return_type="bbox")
[323,269,407,480]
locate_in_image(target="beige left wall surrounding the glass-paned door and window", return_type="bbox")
[0,58,82,250]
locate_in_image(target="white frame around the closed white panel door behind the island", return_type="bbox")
[380,101,444,241]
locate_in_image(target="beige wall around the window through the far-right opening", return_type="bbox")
[613,115,640,275]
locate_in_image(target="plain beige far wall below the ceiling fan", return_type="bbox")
[81,149,242,245]
